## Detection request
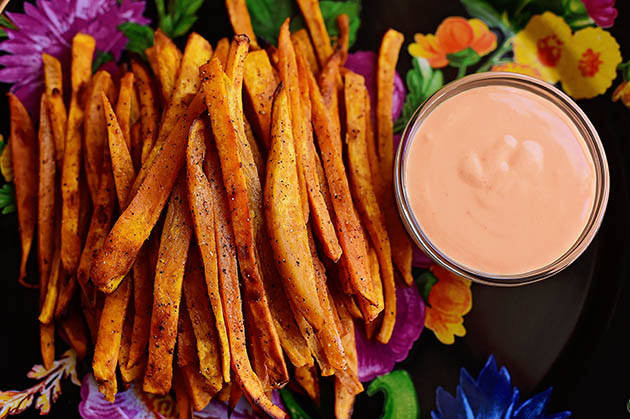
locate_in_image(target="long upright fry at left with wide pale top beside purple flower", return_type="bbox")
[61,33,96,275]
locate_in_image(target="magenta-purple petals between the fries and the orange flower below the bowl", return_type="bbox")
[355,286,424,382]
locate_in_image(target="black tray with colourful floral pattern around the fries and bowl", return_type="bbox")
[0,0,630,418]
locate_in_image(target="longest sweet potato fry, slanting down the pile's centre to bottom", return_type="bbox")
[201,59,288,388]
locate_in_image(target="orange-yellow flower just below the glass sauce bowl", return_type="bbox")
[424,265,472,345]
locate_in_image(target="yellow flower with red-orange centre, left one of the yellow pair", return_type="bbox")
[514,12,571,83]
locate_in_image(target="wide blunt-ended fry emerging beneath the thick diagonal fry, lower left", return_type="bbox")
[143,178,192,394]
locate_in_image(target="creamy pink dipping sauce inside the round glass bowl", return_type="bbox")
[405,86,596,275]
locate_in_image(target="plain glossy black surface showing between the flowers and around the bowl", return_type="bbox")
[0,0,630,418]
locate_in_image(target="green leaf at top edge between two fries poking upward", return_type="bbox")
[247,0,296,45]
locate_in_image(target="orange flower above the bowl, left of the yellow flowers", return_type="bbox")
[409,17,497,68]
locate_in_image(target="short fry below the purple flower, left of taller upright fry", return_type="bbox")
[42,53,68,170]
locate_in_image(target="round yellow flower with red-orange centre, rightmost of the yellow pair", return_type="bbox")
[560,28,621,99]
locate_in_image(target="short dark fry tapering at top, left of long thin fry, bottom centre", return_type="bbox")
[184,248,224,394]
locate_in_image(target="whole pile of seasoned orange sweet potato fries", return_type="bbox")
[9,0,412,418]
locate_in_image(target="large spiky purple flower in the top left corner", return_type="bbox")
[0,0,149,114]
